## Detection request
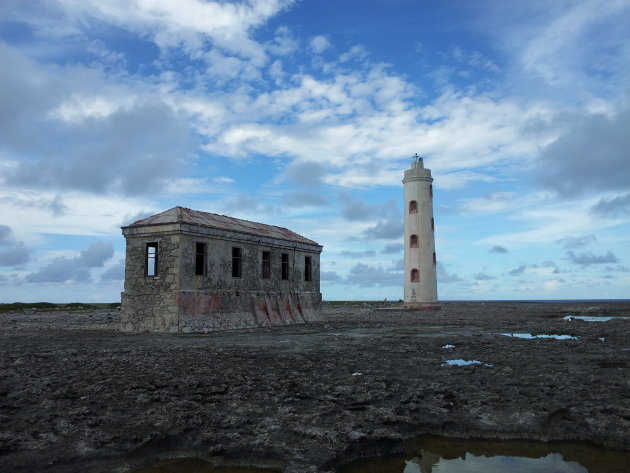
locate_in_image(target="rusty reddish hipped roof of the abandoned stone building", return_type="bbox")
[124,207,321,246]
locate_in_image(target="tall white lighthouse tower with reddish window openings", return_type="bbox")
[403,154,440,310]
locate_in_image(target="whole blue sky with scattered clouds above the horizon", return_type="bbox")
[0,0,630,302]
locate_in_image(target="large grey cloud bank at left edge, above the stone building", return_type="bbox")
[0,43,198,194]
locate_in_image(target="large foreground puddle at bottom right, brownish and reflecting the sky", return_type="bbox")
[339,437,630,473]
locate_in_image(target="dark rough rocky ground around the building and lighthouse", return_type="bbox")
[0,302,630,473]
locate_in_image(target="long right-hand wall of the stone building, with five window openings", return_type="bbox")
[178,228,321,332]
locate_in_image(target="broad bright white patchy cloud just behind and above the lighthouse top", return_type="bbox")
[197,68,557,189]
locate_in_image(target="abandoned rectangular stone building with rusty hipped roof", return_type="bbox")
[122,207,322,332]
